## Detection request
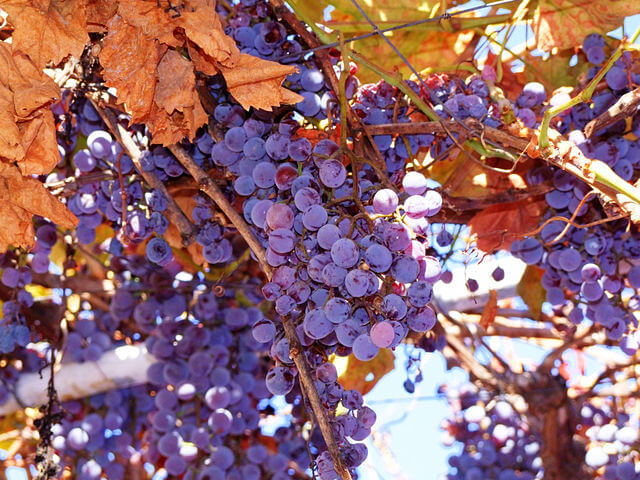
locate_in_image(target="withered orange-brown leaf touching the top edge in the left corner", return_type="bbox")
[0,0,89,68]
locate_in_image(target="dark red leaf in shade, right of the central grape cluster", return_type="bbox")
[469,199,546,253]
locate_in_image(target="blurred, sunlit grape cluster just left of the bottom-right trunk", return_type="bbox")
[442,383,544,480]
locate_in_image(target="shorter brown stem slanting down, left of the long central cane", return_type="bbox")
[89,95,198,246]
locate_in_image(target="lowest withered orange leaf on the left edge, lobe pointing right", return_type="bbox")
[0,162,78,251]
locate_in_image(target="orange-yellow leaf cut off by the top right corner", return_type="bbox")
[533,0,640,52]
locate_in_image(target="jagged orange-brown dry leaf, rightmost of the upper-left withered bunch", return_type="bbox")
[221,53,303,110]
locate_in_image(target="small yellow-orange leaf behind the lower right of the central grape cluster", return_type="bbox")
[333,348,396,395]
